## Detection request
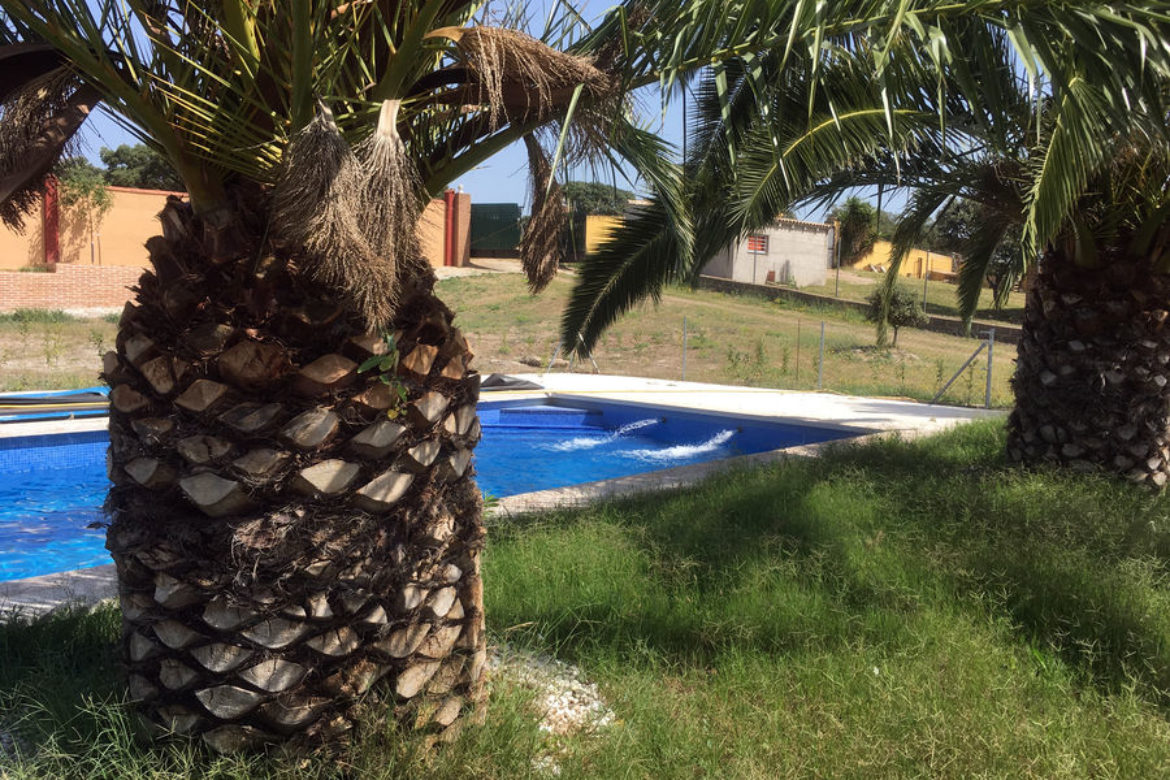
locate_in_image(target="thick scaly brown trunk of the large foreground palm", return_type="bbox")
[104,196,486,750]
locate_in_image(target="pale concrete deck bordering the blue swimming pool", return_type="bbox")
[0,373,1004,620]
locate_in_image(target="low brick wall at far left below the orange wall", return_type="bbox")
[0,264,142,312]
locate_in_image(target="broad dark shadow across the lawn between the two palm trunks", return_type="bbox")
[488,422,1170,707]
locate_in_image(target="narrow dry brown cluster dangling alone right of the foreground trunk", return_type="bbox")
[519,136,569,292]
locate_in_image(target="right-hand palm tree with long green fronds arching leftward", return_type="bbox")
[563,4,1170,485]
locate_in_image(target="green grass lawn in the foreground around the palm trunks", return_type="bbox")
[0,423,1170,778]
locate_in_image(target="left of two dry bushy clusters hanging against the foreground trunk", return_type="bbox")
[273,108,397,327]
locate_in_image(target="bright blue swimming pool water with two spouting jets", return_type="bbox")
[0,401,856,581]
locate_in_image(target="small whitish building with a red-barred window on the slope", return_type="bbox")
[703,218,833,287]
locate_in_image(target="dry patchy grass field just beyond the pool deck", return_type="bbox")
[0,274,1016,406]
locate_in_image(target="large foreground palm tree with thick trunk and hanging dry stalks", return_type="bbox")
[0,0,674,750]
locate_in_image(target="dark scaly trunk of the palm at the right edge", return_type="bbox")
[1007,251,1170,488]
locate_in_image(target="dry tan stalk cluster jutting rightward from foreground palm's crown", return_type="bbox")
[449,27,618,125]
